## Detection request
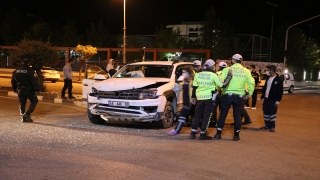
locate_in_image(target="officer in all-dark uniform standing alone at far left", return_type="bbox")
[11,59,39,123]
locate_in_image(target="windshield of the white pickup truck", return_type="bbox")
[113,64,172,78]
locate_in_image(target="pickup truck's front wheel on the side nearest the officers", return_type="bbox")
[155,101,174,129]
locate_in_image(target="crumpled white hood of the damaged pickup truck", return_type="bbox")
[93,78,170,91]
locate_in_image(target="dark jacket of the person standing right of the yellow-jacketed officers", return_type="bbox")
[260,75,283,102]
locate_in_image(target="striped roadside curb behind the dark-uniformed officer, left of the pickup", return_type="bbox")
[4,91,88,108]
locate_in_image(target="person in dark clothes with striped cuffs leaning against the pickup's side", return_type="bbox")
[168,67,194,136]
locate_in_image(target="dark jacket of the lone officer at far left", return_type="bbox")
[11,66,40,91]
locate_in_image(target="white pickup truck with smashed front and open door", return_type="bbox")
[83,61,192,128]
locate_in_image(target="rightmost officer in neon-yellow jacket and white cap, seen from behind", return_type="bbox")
[214,54,254,141]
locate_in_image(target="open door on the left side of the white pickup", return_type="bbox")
[82,64,109,100]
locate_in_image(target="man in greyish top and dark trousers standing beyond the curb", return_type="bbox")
[61,59,75,99]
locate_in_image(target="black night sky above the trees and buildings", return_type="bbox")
[0,0,320,40]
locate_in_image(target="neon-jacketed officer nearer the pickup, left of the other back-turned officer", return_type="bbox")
[190,59,232,140]
